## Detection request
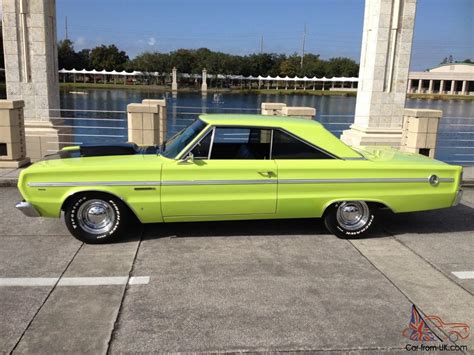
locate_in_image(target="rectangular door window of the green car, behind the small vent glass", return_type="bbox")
[211,127,271,159]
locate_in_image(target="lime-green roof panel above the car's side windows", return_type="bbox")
[199,114,323,129]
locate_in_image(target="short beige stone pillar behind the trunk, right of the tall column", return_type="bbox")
[400,109,443,158]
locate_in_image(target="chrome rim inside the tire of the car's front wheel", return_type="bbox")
[77,200,116,234]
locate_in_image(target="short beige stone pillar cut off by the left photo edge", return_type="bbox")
[0,100,30,168]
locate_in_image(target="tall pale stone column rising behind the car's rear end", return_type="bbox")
[341,0,416,147]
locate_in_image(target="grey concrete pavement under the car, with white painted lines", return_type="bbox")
[0,188,474,354]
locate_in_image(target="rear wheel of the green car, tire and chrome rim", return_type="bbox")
[324,201,376,238]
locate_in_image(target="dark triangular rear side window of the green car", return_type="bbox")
[272,130,332,159]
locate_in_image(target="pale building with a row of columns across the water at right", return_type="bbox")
[408,63,474,95]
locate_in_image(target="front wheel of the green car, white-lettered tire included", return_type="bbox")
[64,193,130,244]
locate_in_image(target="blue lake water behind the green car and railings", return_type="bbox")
[61,90,474,165]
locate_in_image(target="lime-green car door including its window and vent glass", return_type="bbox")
[161,126,277,220]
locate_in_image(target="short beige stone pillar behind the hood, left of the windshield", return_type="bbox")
[127,100,166,145]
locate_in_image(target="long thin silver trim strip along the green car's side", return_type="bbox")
[28,178,454,187]
